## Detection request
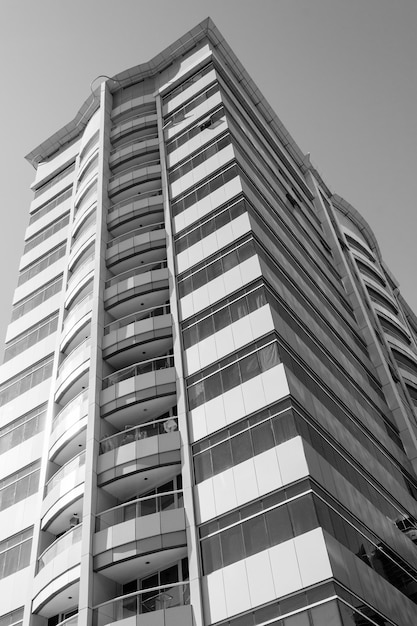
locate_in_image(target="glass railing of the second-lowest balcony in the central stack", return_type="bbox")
[96,491,184,532]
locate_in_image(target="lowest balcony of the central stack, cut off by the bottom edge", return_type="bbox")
[93,582,190,626]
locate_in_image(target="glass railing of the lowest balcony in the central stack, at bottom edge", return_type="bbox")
[93,582,190,626]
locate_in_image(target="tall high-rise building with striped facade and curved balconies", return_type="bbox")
[0,20,417,626]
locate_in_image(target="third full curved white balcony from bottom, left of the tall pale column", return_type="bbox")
[49,389,88,465]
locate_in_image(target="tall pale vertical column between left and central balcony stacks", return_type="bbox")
[78,82,112,626]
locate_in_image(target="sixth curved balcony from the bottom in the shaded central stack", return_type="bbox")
[104,261,169,317]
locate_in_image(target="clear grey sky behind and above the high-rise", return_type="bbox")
[0,0,417,351]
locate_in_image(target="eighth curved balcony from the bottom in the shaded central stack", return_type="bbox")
[107,188,164,236]
